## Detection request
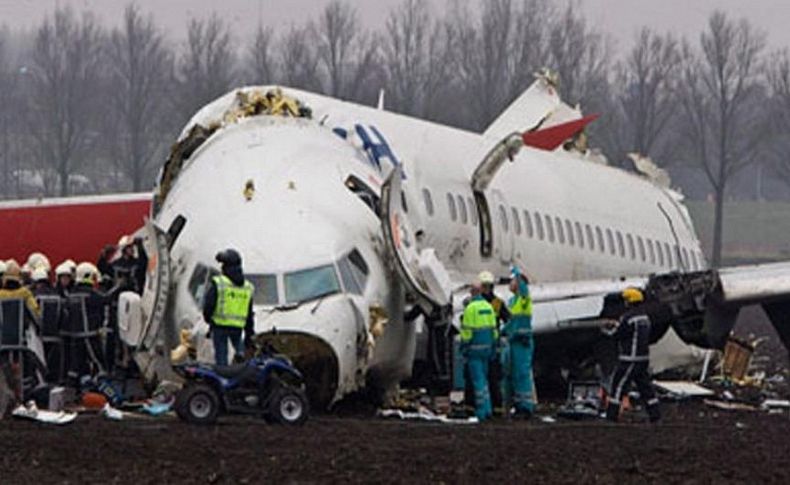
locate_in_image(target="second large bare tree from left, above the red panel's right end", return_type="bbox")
[108,4,173,191]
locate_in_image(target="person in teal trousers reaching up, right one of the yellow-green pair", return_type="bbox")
[503,268,535,418]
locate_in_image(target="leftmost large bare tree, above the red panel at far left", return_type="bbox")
[30,9,102,196]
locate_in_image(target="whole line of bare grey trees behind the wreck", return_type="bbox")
[0,0,790,264]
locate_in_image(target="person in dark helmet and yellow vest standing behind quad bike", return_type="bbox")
[203,249,255,366]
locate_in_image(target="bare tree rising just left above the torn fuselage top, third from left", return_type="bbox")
[174,14,236,119]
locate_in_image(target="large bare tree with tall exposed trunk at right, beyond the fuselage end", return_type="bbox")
[682,11,767,267]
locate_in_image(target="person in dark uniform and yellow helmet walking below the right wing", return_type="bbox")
[606,288,661,423]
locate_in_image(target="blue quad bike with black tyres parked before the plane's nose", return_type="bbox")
[174,347,309,425]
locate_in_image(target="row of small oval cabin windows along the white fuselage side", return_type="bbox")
[422,188,704,269]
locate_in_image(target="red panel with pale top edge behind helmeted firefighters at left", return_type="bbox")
[0,194,151,269]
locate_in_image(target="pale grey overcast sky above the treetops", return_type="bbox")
[0,0,790,53]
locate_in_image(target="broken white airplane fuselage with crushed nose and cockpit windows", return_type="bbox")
[117,80,790,403]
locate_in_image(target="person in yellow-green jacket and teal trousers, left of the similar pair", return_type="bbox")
[461,283,497,421]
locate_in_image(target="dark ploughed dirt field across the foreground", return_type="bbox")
[0,310,790,484]
